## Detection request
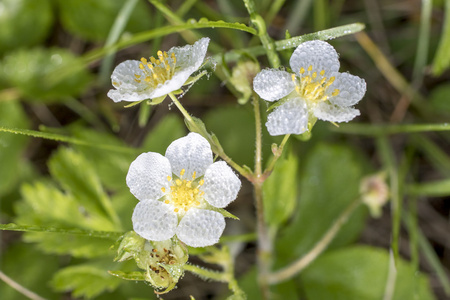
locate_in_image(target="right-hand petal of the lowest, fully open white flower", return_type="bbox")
[201,161,241,208]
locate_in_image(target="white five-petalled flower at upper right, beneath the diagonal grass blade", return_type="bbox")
[253,41,366,135]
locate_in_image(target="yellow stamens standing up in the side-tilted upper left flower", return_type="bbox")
[134,50,177,88]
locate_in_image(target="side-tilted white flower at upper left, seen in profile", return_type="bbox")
[108,38,209,102]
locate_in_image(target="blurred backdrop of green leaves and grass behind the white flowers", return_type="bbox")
[0,0,450,299]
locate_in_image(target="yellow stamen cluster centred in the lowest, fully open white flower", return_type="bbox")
[161,169,205,213]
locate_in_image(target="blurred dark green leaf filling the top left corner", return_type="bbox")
[0,0,53,53]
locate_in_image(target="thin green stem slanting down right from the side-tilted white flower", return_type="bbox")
[168,93,251,181]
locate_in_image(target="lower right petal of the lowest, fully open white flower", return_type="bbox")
[177,208,225,247]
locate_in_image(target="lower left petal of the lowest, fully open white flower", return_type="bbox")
[131,200,178,241]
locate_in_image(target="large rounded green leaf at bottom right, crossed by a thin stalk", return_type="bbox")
[301,246,435,300]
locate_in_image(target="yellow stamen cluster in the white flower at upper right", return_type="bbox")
[292,66,339,103]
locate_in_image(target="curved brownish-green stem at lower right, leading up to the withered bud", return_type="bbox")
[269,198,361,284]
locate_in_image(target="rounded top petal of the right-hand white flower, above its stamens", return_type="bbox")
[289,40,339,77]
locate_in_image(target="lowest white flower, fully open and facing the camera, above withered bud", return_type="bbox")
[127,133,241,247]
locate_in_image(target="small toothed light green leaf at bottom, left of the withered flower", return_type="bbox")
[51,262,121,298]
